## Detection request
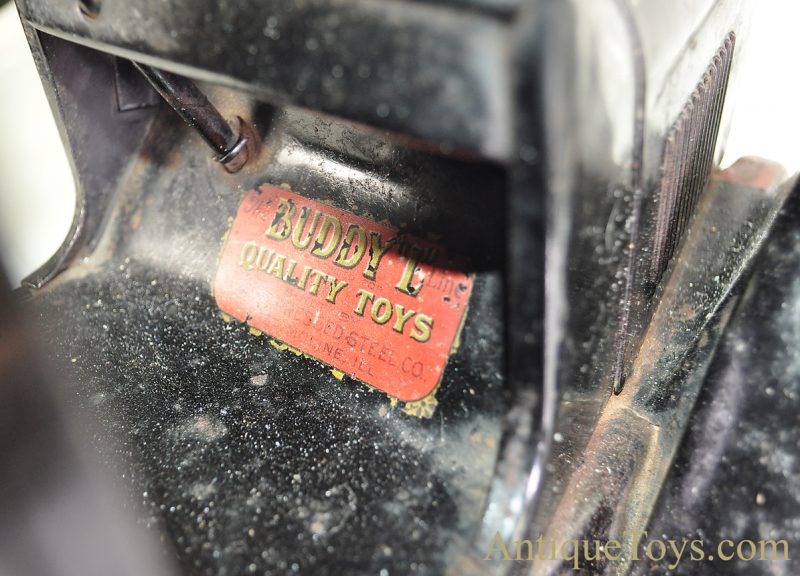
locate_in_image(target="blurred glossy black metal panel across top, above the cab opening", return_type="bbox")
[18,0,518,160]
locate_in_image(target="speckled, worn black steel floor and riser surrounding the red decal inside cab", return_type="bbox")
[29,83,504,574]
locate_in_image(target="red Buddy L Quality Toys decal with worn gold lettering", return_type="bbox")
[214,186,472,401]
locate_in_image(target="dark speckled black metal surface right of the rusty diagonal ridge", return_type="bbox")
[634,178,800,575]
